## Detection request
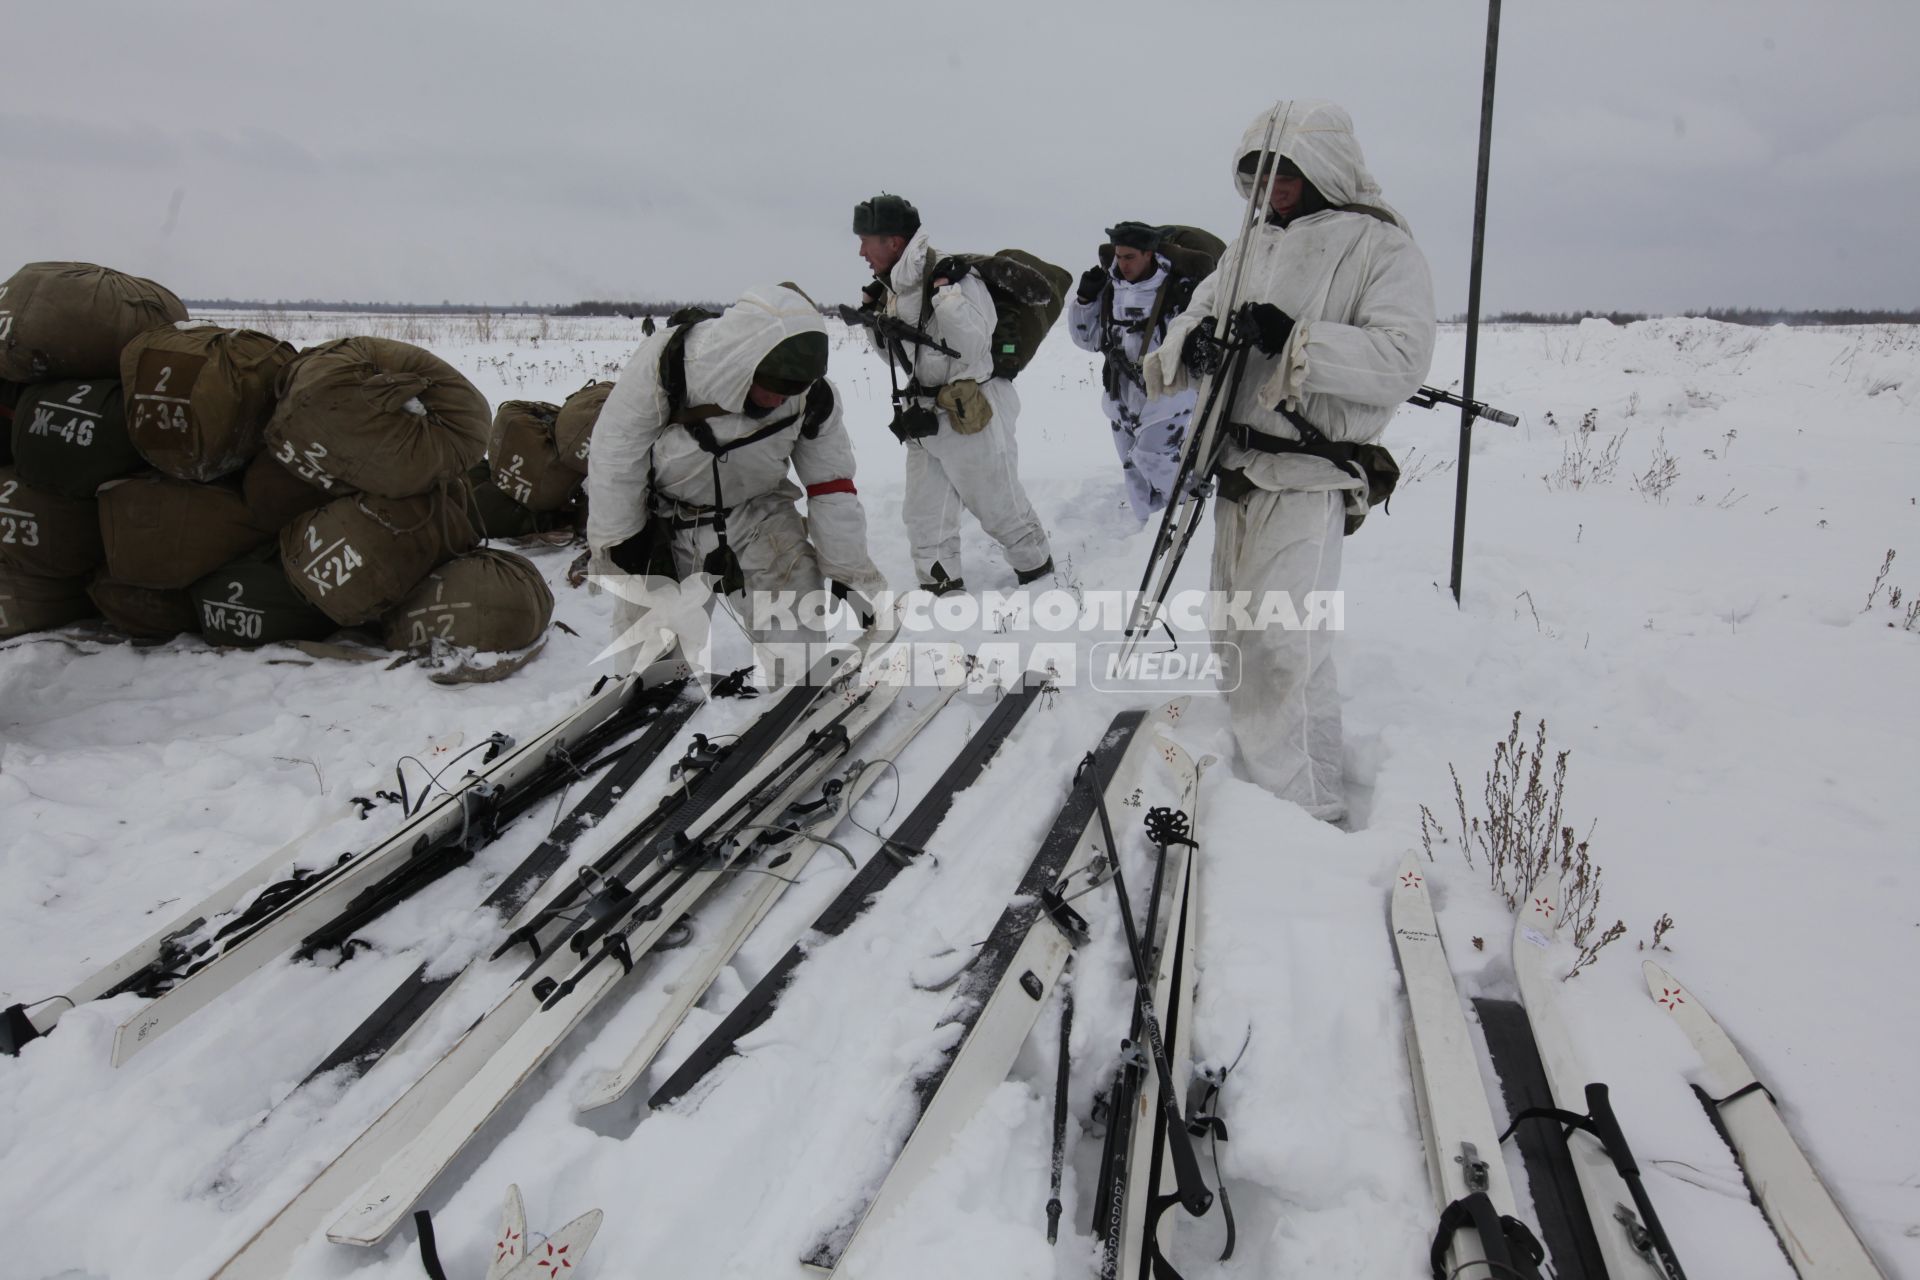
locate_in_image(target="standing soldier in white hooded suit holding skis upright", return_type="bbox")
[1142,100,1434,821]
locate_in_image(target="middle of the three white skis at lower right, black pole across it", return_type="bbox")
[1513,881,1667,1280]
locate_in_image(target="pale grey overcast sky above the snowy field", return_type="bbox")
[0,0,1920,315]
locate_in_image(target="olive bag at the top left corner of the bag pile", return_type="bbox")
[0,263,186,382]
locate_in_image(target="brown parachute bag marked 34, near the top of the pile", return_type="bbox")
[121,324,294,482]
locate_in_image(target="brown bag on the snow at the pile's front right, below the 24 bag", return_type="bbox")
[384,547,553,652]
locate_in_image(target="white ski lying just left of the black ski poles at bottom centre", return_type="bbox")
[801,699,1188,1274]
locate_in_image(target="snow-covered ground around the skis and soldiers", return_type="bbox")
[0,317,1920,1280]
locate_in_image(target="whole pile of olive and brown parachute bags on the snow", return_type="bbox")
[0,263,587,652]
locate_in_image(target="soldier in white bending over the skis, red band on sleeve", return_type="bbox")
[588,284,887,656]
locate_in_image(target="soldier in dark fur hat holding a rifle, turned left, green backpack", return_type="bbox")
[852,194,1069,595]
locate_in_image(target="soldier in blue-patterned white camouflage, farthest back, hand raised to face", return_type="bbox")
[1068,223,1223,522]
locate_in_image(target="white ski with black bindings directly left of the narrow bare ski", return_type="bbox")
[326,652,899,1245]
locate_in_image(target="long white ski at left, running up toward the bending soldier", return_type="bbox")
[113,664,684,1067]
